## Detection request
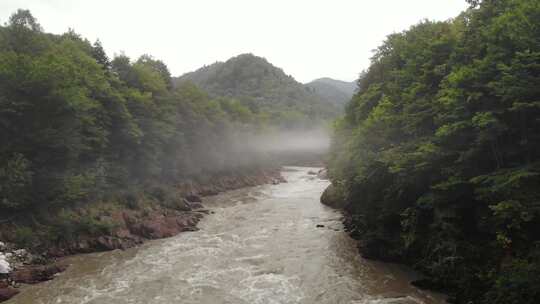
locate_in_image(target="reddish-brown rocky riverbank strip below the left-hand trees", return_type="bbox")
[0,168,287,302]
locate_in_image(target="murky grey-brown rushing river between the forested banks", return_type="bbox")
[7,167,444,304]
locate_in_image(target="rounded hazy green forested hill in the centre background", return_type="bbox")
[174,54,339,128]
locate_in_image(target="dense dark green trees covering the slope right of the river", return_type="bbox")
[330,0,540,304]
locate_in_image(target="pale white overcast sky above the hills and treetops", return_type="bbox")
[0,0,467,82]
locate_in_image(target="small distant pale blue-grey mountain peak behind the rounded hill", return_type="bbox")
[304,78,356,107]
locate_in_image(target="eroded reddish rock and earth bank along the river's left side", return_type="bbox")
[0,169,286,302]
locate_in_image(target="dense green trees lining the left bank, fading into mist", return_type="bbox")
[0,10,270,216]
